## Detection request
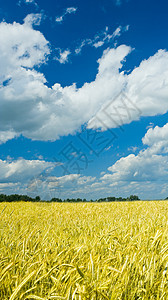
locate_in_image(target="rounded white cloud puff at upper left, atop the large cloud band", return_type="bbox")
[0,19,50,69]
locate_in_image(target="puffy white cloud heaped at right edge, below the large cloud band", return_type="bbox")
[101,123,168,183]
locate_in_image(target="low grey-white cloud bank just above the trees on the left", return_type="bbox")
[0,158,96,200]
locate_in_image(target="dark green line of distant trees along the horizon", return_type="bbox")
[0,194,140,202]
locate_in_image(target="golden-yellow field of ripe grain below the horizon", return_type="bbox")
[0,201,168,300]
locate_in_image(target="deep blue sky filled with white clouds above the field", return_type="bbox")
[0,0,168,200]
